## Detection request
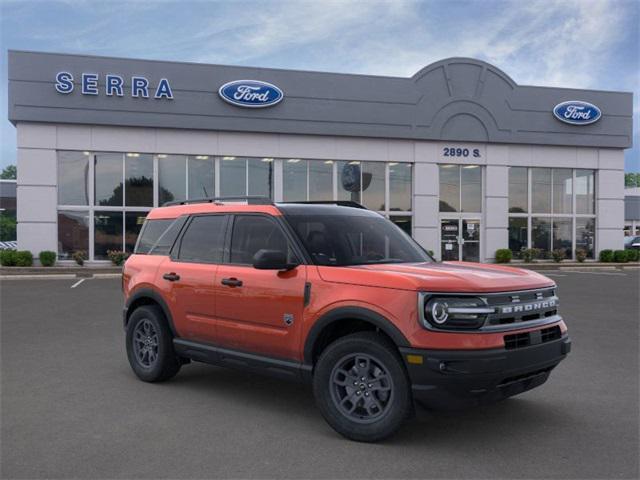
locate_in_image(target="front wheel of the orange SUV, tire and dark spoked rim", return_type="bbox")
[313,332,413,442]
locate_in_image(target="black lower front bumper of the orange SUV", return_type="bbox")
[400,334,571,409]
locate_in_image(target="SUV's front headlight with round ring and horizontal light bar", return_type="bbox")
[422,297,495,330]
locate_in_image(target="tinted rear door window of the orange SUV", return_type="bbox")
[177,215,227,263]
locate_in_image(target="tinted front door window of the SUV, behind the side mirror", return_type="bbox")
[230,215,292,265]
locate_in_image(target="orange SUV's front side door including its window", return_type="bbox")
[215,214,306,359]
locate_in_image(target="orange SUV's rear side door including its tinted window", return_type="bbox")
[158,214,229,343]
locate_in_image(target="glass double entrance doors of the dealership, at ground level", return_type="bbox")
[440,218,480,262]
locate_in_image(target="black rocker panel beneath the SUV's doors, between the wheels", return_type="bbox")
[173,338,312,382]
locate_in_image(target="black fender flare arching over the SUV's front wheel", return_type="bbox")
[304,307,411,365]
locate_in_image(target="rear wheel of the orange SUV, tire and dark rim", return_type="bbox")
[126,305,182,382]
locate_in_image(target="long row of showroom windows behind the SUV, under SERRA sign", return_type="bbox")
[58,151,416,260]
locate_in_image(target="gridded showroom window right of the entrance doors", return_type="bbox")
[509,167,595,259]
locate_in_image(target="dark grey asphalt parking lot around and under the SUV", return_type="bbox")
[0,270,640,478]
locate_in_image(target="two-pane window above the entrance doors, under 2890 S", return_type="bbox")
[438,165,482,213]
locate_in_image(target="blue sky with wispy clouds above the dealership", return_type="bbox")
[0,0,640,172]
